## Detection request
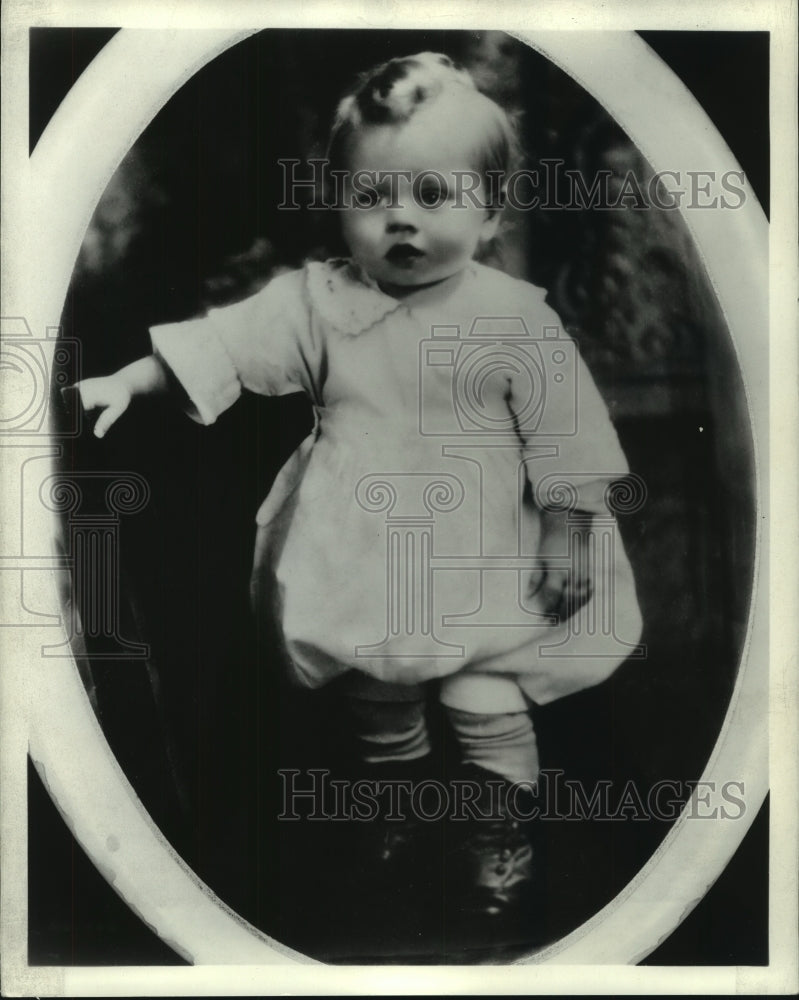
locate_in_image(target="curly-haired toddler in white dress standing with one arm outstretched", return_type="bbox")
[80,53,638,909]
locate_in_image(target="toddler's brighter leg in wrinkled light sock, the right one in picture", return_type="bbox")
[440,674,539,782]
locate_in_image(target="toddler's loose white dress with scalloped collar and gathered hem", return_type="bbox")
[151,260,640,703]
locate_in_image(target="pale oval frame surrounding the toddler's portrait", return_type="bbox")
[20,29,768,965]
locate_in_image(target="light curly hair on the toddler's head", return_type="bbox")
[327,52,520,186]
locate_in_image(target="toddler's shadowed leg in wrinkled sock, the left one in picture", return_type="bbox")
[341,671,430,764]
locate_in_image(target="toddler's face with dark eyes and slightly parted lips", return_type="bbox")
[342,102,498,296]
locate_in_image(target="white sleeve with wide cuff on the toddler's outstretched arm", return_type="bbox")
[150,271,323,424]
